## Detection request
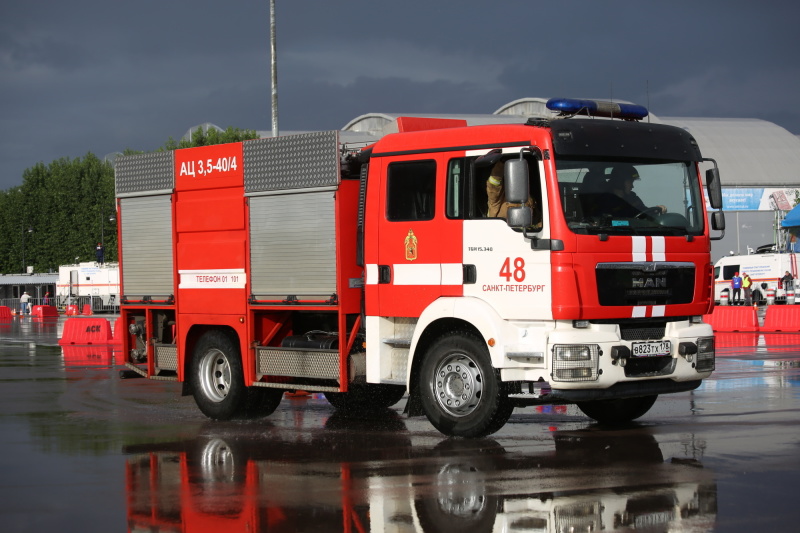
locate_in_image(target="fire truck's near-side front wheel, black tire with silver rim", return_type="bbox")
[419,331,514,437]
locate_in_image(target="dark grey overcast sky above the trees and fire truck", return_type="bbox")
[0,0,800,189]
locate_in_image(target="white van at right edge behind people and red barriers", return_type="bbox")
[714,252,800,304]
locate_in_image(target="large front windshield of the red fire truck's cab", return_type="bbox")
[556,158,705,235]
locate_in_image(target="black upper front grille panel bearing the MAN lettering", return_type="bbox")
[595,262,695,306]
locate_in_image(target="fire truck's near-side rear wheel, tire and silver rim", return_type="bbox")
[189,330,250,420]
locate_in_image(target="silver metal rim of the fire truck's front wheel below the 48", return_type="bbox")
[433,353,483,417]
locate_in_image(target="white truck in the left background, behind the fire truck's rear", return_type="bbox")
[55,261,119,312]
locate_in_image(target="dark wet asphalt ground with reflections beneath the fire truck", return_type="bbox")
[0,317,800,532]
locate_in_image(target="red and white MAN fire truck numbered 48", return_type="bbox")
[116,99,724,437]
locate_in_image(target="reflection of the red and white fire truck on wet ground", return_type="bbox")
[125,420,717,533]
